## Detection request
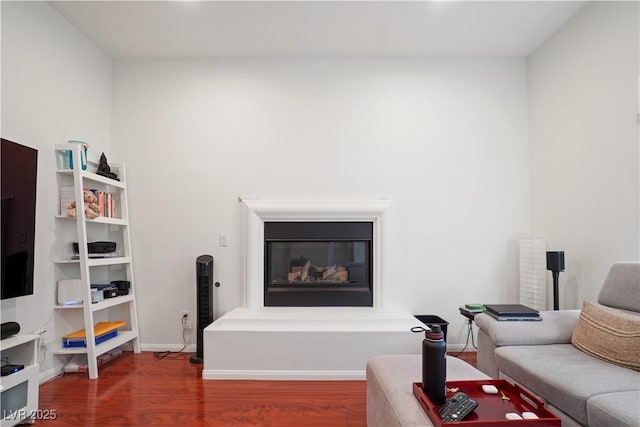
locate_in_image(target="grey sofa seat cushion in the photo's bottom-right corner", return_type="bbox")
[587,391,640,427]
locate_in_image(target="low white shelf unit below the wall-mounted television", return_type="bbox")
[0,334,40,427]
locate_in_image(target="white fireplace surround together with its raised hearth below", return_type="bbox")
[202,199,422,380]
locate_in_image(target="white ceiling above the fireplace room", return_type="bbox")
[50,0,585,59]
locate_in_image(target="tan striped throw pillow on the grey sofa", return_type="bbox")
[571,302,640,370]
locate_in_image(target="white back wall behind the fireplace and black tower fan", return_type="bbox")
[112,58,529,349]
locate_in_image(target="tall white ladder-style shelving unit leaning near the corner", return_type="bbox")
[54,144,140,379]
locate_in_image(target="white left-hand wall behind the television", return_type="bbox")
[0,1,111,378]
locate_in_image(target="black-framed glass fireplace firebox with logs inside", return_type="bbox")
[264,221,373,307]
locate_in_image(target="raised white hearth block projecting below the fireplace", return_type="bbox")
[202,307,422,380]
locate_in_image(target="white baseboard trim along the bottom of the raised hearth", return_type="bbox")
[202,369,366,381]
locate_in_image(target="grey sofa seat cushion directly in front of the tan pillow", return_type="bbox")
[495,344,640,425]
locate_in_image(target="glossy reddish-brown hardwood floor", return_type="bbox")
[37,352,475,427]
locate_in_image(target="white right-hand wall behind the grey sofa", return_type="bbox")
[527,2,640,308]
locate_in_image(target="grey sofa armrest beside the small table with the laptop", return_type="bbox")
[474,310,580,347]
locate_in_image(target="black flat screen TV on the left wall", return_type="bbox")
[0,139,38,299]
